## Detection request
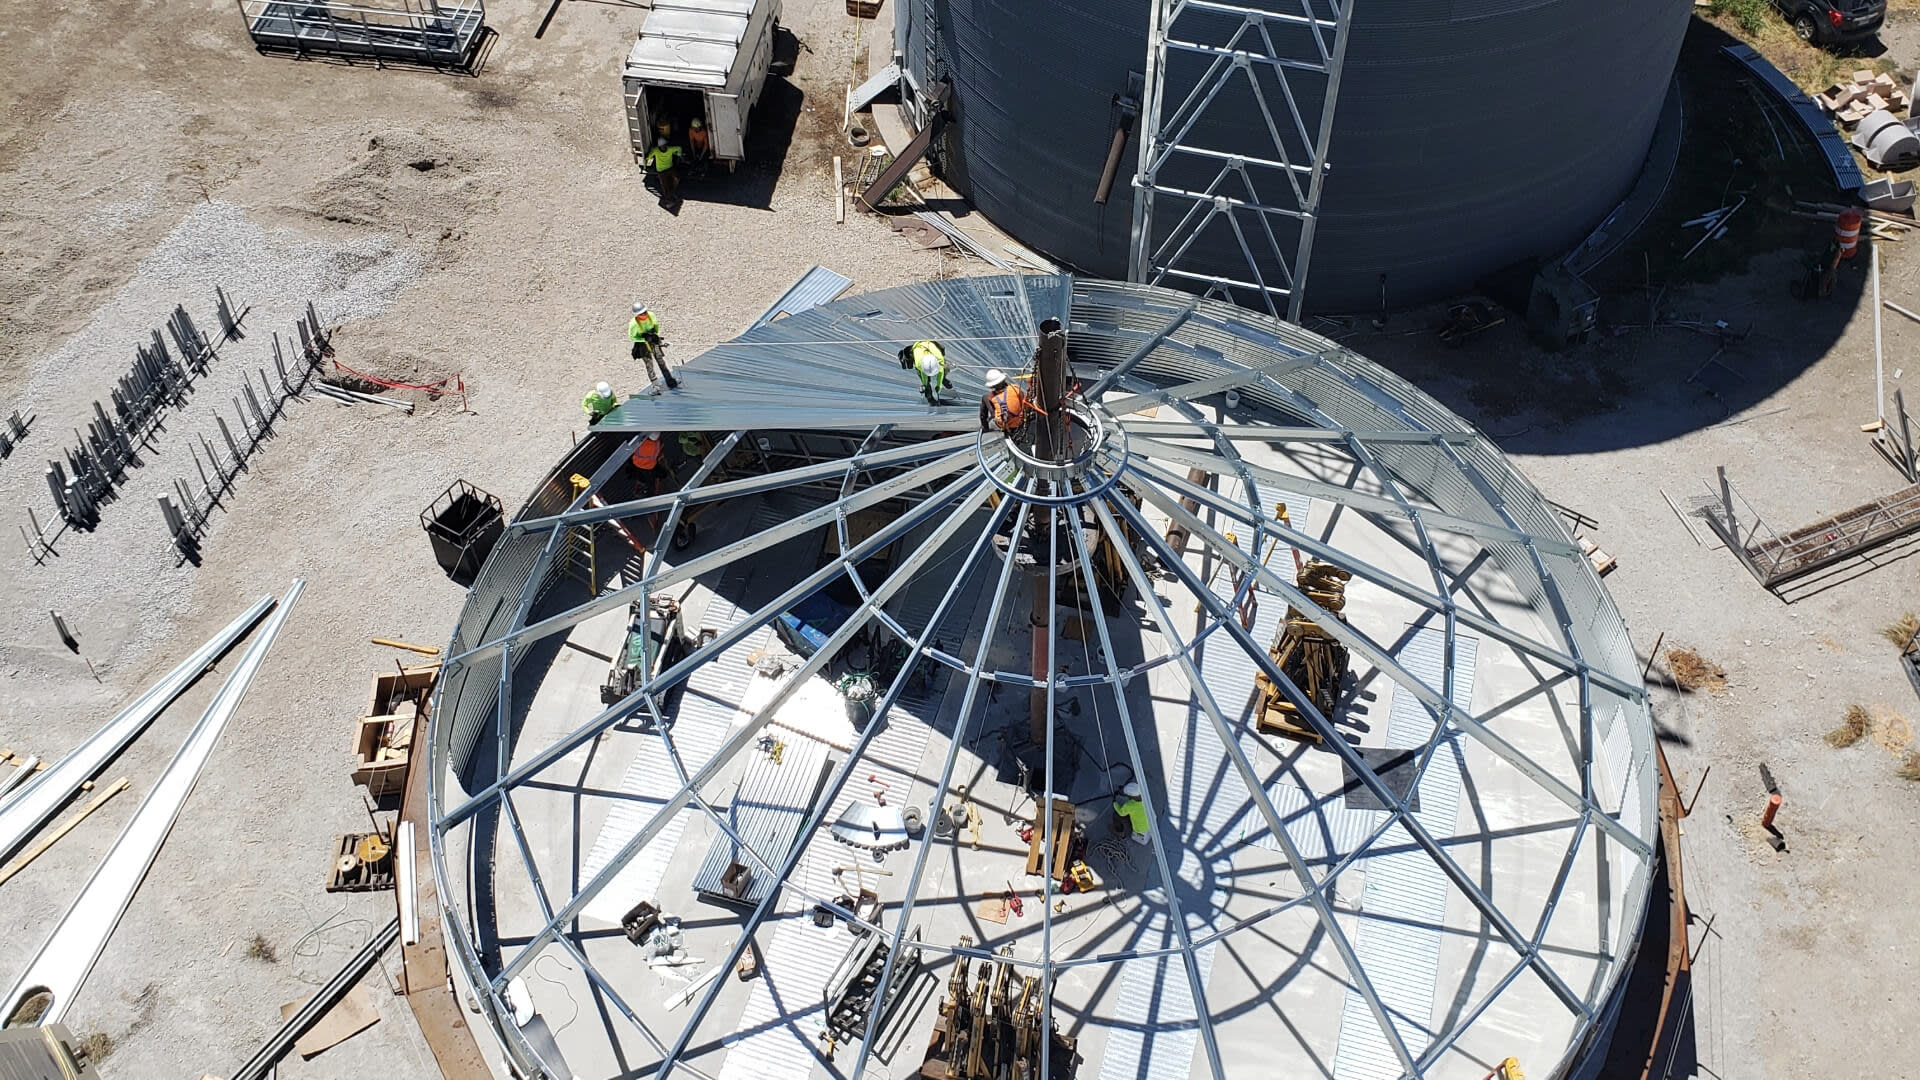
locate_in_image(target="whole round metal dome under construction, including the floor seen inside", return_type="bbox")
[430,277,1657,1080]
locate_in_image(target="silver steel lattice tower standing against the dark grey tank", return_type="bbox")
[1127,0,1354,323]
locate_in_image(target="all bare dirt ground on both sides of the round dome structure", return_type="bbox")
[0,0,1920,1080]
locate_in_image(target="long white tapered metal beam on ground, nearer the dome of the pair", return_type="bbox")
[0,578,307,1024]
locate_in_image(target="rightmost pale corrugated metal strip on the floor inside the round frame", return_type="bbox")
[1332,628,1480,1080]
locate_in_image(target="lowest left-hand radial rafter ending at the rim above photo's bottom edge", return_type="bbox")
[487,480,1004,991]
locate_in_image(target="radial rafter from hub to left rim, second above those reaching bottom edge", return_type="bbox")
[440,463,989,832]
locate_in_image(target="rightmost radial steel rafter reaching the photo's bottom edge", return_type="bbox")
[1083,502,1419,1076]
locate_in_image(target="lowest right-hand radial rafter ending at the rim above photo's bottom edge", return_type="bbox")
[1116,500,1592,1017]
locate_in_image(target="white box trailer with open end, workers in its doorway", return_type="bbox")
[622,0,780,169]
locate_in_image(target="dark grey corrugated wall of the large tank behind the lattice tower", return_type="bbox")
[895,0,1692,311]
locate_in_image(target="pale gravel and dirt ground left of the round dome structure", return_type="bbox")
[0,0,954,1080]
